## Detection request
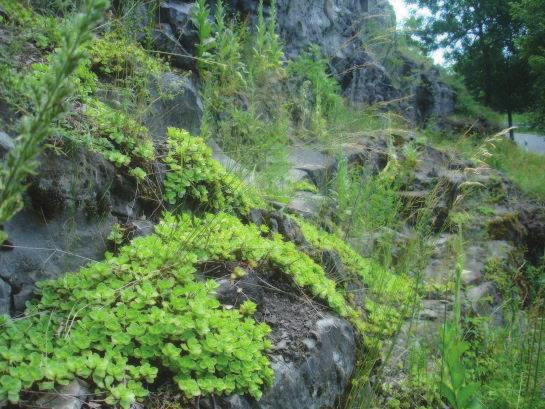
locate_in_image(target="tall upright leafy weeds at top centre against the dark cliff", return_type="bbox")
[197,1,289,194]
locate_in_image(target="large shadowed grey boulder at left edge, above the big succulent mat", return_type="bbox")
[0,148,151,313]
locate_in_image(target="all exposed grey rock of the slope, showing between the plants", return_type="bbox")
[0,0,545,409]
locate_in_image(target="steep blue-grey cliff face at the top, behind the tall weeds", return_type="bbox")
[154,0,456,124]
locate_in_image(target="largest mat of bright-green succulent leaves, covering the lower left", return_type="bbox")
[0,215,273,408]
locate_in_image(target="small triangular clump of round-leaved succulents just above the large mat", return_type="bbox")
[163,128,260,213]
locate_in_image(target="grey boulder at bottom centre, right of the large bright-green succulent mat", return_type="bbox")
[196,264,358,409]
